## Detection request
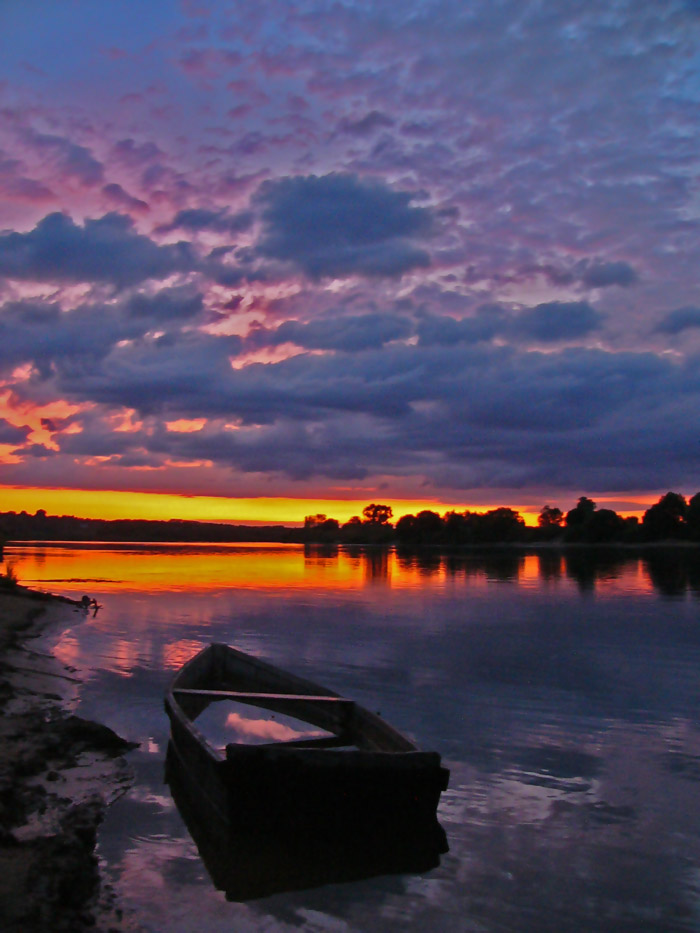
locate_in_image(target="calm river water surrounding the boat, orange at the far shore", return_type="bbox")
[6,545,700,933]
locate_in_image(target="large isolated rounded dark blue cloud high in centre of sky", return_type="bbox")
[254,174,433,279]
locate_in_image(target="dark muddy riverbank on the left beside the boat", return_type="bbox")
[0,586,134,933]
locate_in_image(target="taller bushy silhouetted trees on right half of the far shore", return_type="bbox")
[304,492,700,548]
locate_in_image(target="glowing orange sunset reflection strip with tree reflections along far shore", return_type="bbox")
[4,542,700,598]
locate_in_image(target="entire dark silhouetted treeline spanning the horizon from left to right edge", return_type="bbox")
[0,492,700,548]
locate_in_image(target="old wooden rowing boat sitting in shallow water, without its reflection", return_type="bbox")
[165,644,449,831]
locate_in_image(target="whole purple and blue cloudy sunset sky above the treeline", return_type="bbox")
[0,0,700,520]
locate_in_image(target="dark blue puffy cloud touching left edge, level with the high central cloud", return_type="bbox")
[0,213,196,287]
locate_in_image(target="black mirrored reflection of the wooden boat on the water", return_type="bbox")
[166,743,448,901]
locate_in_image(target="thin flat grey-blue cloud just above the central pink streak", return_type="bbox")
[246,313,412,353]
